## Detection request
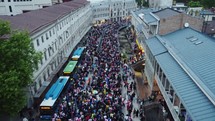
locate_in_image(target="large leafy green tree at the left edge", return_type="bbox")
[0,20,41,116]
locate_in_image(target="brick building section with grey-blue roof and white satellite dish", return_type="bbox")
[153,8,203,35]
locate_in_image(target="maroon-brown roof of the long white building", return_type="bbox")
[0,0,89,34]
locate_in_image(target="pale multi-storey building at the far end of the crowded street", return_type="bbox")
[91,0,137,23]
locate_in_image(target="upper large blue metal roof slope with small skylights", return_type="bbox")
[164,28,215,101]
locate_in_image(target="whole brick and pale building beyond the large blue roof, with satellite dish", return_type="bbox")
[131,8,203,48]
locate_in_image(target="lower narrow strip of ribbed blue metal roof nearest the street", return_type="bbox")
[155,53,215,121]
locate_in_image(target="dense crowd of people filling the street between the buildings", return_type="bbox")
[53,21,146,121]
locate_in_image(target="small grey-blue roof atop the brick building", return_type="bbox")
[153,8,181,19]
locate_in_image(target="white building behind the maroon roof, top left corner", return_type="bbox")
[0,0,52,16]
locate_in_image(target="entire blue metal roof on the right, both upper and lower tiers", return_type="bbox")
[146,28,215,121]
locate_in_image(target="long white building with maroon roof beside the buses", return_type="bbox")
[0,0,92,105]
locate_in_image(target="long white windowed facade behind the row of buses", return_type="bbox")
[32,1,92,106]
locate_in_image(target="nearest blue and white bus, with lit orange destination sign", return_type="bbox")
[40,76,69,120]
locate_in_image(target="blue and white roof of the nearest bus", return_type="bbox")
[40,76,69,106]
